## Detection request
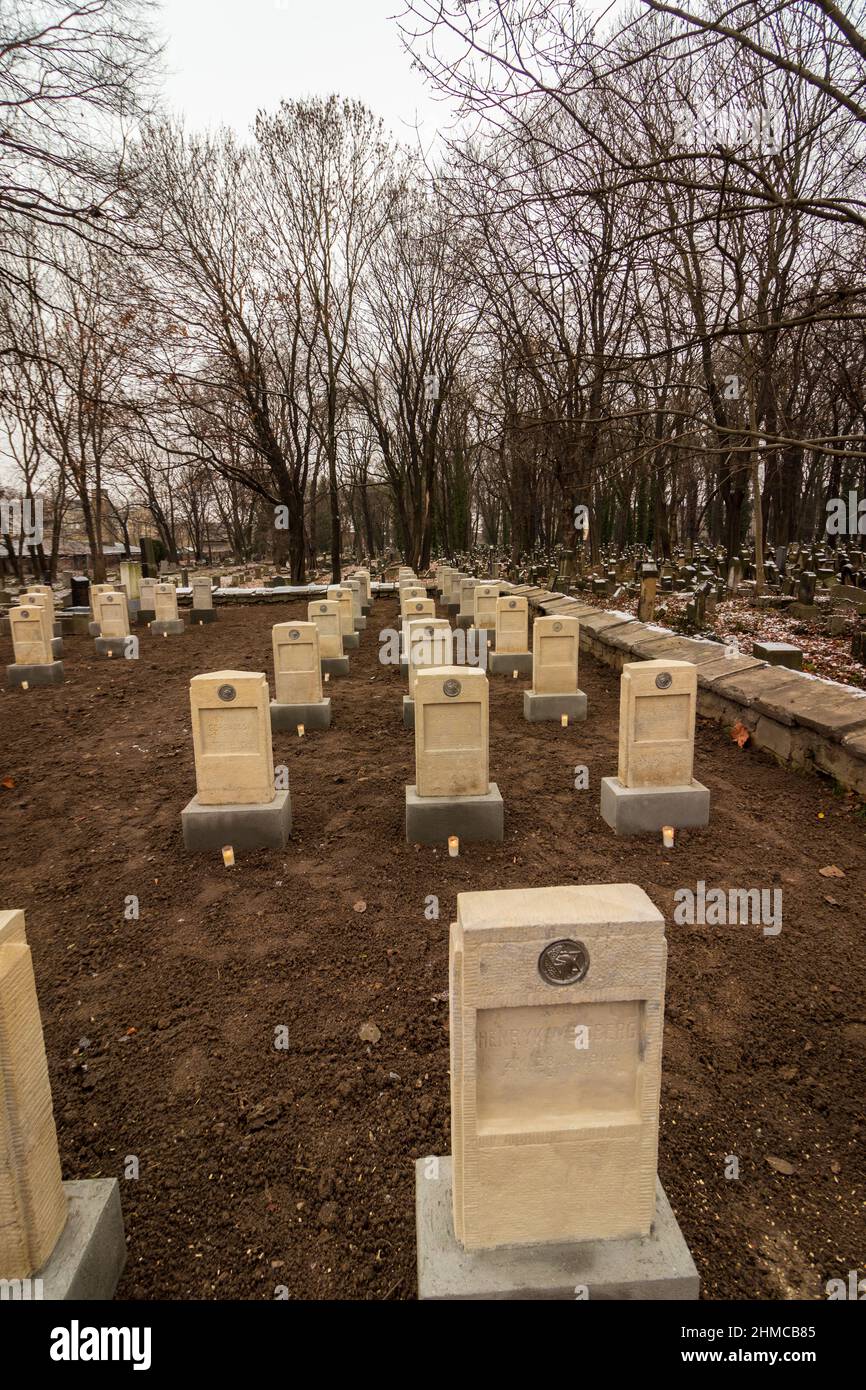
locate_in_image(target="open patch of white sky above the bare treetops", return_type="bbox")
[160,0,450,142]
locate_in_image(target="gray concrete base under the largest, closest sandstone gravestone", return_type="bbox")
[416,1156,701,1302]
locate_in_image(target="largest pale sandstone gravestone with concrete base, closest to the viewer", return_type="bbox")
[416,884,698,1300]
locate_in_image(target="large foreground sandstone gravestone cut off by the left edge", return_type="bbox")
[0,912,126,1300]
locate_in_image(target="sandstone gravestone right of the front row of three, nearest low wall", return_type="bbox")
[601,660,710,835]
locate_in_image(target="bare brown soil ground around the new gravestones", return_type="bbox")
[0,599,866,1300]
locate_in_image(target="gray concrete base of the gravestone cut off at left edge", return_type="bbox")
[33,1177,126,1302]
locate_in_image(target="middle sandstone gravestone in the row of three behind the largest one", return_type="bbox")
[406,666,503,845]
